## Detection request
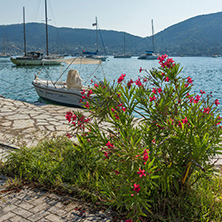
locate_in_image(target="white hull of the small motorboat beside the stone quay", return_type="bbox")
[32,80,83,107]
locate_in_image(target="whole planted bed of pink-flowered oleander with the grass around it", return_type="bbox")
[2,55,222,222]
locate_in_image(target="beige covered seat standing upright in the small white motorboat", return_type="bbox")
[66,69,83,90]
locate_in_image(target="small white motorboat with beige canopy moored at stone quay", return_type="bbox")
[32,57,102,107]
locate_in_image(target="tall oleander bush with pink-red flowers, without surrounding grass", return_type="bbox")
[66,55,221,220]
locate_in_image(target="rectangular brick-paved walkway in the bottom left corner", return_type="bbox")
[0,175,113,222]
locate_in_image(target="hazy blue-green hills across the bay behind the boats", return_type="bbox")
[0,12,222,56]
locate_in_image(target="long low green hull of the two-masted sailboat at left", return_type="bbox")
[10,57,61,66]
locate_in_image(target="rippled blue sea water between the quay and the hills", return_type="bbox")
[0,56,222,114]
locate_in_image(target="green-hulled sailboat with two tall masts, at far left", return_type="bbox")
[10,0,63,66]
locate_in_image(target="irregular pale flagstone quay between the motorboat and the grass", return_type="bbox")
[0,98,81,147]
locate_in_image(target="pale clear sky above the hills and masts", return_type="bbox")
[0,0,222,37]
